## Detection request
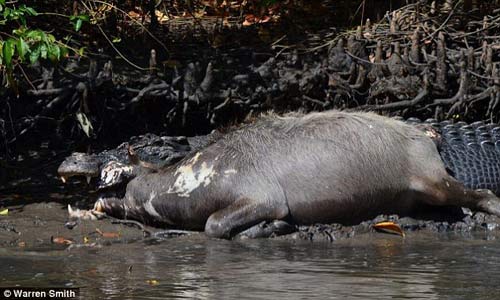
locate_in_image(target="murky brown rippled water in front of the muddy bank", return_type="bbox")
[0,232,500,299]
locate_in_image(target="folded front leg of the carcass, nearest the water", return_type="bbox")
[205,198,288,238]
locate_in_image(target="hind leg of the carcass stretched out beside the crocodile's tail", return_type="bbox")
[415,176,500,216]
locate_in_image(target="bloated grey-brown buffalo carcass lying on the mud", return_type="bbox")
[95,111,500,238]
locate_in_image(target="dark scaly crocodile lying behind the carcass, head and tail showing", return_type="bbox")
[58,118,500,195]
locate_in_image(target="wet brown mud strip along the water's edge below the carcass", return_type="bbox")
[0,202,500,251]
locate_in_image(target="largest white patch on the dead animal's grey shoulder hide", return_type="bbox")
[167,152,216,197]
